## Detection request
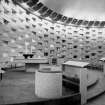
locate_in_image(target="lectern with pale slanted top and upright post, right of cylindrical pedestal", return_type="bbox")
[62,61,89,105]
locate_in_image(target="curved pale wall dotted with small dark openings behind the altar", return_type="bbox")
[0,1,105,64]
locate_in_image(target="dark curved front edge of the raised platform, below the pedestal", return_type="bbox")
[5,93,81,105]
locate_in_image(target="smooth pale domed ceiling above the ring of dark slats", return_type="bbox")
[40,0,105,20]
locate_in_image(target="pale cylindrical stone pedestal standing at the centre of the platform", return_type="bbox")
[35,70,62,98]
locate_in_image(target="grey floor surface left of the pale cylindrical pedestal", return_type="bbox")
[0,72,42,105]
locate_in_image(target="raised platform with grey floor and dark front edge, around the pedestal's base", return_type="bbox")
[0,71,80,105]
